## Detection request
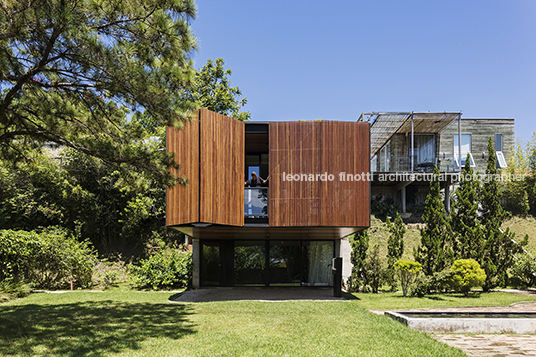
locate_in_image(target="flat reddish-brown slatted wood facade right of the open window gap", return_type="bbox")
[269,121,370,227]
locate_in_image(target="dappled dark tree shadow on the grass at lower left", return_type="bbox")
[0,301,195,356]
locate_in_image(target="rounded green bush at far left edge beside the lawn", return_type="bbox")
[0,227,97,289]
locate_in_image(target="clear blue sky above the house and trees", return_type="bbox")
[192,0,536,140]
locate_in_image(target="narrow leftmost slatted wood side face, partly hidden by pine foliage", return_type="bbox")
[166,119,199,226]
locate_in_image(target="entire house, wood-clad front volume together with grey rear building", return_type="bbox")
[166,109,514,287]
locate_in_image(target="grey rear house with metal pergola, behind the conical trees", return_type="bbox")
[360,112,514,213]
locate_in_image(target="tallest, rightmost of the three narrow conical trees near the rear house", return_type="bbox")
[481,138,528,291]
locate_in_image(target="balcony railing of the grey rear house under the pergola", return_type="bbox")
[371,154,460,172]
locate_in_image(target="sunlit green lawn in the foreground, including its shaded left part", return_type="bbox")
[0,291,464,356]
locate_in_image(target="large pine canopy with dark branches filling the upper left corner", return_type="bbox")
[0,0,197,183]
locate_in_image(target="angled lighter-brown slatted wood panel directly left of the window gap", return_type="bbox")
[199,109,245,226]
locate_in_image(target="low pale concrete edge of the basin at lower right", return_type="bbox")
[385,311,536,335]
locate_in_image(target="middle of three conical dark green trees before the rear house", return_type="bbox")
[450,153,484,261]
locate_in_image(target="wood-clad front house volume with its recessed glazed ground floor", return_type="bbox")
[166,109,370,287]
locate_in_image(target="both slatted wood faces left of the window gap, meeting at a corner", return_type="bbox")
[166,109,244,226]
